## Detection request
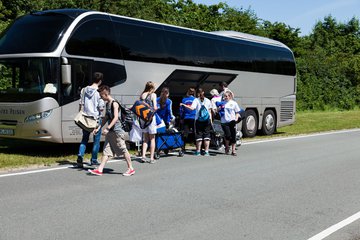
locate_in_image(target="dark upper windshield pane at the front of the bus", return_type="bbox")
[0,13,73,54]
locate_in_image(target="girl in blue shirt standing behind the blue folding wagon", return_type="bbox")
[156,87,175,129]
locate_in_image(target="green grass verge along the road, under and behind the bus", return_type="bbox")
[0,110,360,170]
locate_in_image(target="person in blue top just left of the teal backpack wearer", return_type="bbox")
[180,88,196,142]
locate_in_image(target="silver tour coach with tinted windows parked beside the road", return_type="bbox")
[0,9,296,143]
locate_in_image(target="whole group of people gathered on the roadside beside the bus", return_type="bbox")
[77,72,240,176]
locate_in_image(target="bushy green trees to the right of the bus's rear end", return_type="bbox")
[297,16,360,110]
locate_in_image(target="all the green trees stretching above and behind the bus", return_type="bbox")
[0,0,360,110]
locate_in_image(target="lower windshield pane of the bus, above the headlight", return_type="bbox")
[0,58,59,102]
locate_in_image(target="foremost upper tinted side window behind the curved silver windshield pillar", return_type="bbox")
[66,20,121,59]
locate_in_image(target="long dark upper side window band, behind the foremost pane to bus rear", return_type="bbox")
[109,15,295,75]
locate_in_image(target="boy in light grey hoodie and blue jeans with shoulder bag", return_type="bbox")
[76,72,104,168]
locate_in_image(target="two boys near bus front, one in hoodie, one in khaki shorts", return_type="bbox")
[77,72,135,176]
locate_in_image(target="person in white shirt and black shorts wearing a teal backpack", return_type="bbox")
[180,88,213,156]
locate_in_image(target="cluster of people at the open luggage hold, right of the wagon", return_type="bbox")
[180,82,240,156]
